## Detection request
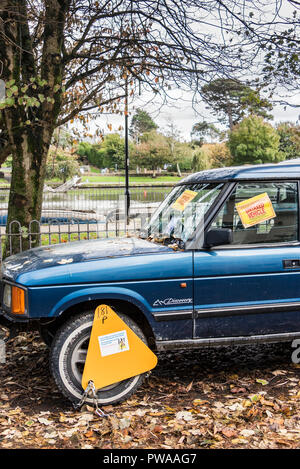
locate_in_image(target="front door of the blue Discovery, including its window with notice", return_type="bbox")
[194,181,300,338]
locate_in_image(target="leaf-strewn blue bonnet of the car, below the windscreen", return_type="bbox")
[2,238,174,285]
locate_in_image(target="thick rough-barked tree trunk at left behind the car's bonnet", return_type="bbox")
[0,0,70,257]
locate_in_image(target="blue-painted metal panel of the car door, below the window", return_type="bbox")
[194,245,300,338]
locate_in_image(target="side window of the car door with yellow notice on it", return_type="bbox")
[211,181,298,245]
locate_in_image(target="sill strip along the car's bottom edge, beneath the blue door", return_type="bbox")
[156,332,300,351]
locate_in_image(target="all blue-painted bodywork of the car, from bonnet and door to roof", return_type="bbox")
[2,164,300,340]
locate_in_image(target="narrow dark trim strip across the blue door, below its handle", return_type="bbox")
[196,301,300,318]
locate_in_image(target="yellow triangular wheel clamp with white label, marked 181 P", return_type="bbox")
[81,305,157,390]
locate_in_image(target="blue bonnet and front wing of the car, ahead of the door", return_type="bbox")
[3,238,193,340]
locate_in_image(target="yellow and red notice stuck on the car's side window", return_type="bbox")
[235,192,276,228]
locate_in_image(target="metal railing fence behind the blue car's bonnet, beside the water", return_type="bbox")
[0,185,171,260]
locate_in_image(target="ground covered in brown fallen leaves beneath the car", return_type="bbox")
[0,326,300,449]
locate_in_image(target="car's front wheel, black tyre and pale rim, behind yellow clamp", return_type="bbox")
[50,311,147,405]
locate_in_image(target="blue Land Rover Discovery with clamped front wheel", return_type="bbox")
[0,164,300,404]
